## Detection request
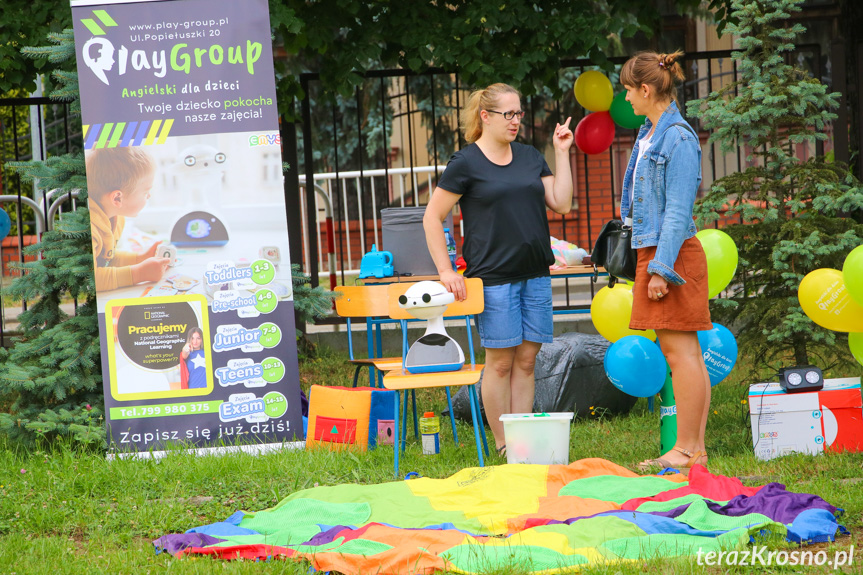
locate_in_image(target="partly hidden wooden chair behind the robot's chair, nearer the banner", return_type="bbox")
[335,285,402,387]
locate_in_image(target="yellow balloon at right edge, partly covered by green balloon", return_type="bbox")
[797,268,863,332]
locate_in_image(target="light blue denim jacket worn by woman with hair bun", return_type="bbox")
[620,102,701,285]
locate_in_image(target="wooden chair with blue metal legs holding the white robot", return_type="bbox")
[383,278,488,477]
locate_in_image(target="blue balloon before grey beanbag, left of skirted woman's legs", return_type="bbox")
[603,335,668,397]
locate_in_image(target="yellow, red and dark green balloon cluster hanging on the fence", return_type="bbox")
[573,70,645,154]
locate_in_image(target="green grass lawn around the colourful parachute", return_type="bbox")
[0,344,863,574]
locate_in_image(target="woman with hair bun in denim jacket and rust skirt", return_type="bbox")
[620,51,713,473]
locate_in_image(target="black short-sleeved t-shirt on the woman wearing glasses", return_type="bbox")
[438,142,554,285]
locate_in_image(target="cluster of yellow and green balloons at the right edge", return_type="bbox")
[797,245,863,365]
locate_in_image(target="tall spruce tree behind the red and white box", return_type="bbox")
[688,0,863,375]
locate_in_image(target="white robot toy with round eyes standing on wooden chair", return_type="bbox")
[399,281,464,373]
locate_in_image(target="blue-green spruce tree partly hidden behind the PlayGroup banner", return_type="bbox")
[0,30,332,446]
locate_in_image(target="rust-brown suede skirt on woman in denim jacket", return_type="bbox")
[629,237,713,331]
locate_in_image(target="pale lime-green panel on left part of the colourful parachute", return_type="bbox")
[268,481,485,533]
